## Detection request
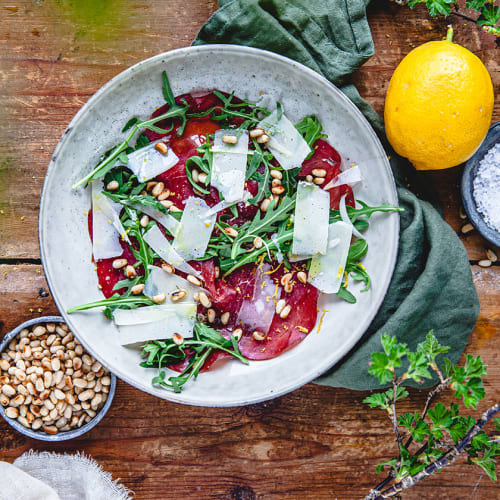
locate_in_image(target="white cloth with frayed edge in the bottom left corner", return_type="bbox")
[0,451,133,500]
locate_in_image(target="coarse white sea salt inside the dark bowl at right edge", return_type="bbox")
[473,142,500,233]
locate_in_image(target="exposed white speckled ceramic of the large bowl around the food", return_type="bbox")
[40,45,399,406]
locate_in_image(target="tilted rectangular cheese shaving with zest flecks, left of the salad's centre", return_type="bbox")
[174,196,215,259]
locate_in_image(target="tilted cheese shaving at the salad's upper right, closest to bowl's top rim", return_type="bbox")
[257,110,311,170]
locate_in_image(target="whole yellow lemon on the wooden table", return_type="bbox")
[384,32,494,170]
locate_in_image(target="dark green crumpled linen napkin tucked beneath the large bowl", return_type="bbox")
[193,0,479,390]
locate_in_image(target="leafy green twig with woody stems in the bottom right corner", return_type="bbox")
[364,331,500,500]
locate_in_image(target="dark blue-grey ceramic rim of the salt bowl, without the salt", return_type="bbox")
[462,122,500,246]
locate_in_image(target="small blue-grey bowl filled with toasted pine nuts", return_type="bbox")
[0,316,116,441]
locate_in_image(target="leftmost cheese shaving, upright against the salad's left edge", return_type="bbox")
[91,181,130,260]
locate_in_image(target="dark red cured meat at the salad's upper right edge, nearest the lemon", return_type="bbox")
[299,139,355,210]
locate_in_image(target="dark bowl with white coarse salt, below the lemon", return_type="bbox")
[462,122,500,246]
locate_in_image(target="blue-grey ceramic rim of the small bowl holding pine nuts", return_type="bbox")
[0,316,116,442]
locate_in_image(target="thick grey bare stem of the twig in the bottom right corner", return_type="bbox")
[365,403,500,500]
